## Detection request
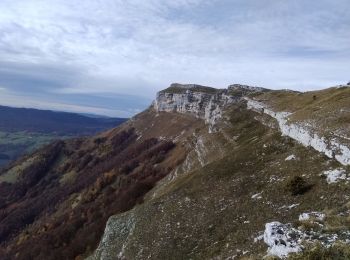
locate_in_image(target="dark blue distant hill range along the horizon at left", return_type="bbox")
[0,106,126,136]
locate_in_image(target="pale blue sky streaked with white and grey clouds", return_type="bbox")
[0,0,350,117]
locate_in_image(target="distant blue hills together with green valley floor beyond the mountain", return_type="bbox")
[0,106,126,167]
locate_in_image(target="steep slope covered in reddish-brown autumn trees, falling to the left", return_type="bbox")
[0,111,202,259]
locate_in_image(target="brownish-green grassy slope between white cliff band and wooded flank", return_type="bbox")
[91,103,350,259]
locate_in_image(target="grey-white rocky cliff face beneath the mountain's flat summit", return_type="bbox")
[153,84,239,132]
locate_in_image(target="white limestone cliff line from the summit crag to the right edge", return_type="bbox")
[154,83,350,165]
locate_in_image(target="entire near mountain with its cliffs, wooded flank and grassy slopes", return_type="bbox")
[0,84,350,259]
